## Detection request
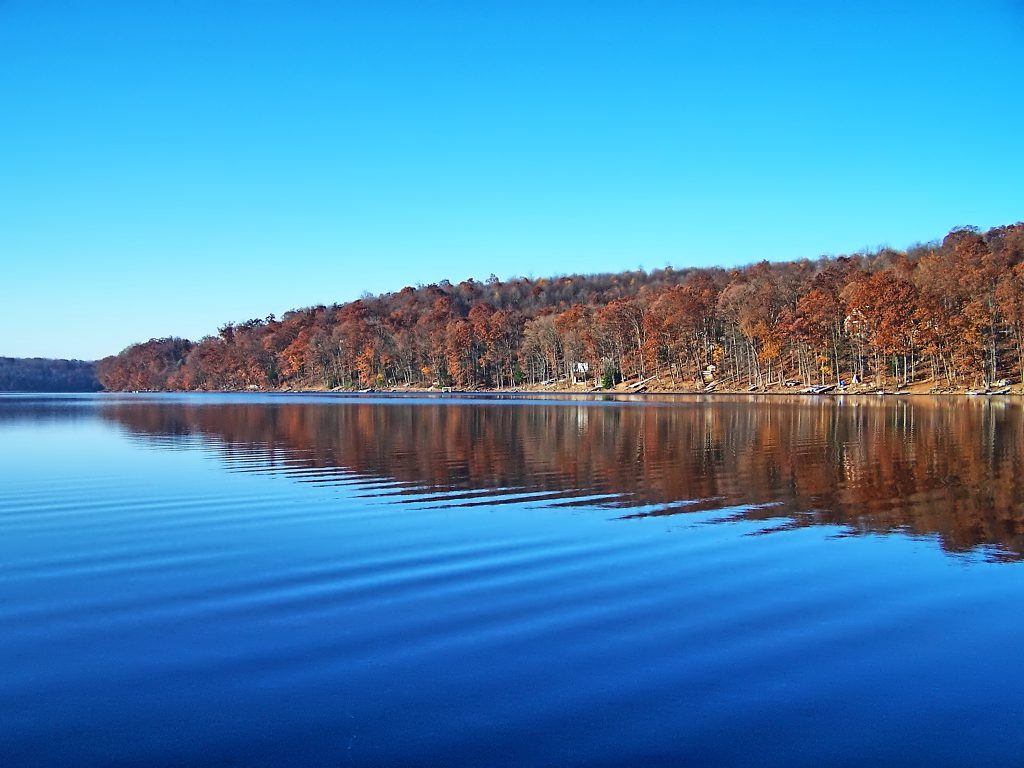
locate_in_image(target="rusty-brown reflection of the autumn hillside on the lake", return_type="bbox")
[86,398,1024,559]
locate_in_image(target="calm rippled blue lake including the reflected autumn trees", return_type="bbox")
[0,394,1024,766]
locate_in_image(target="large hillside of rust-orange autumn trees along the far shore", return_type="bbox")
[98,223,1024,390]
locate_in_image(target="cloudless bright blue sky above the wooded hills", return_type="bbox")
[0,0,1024,358]
